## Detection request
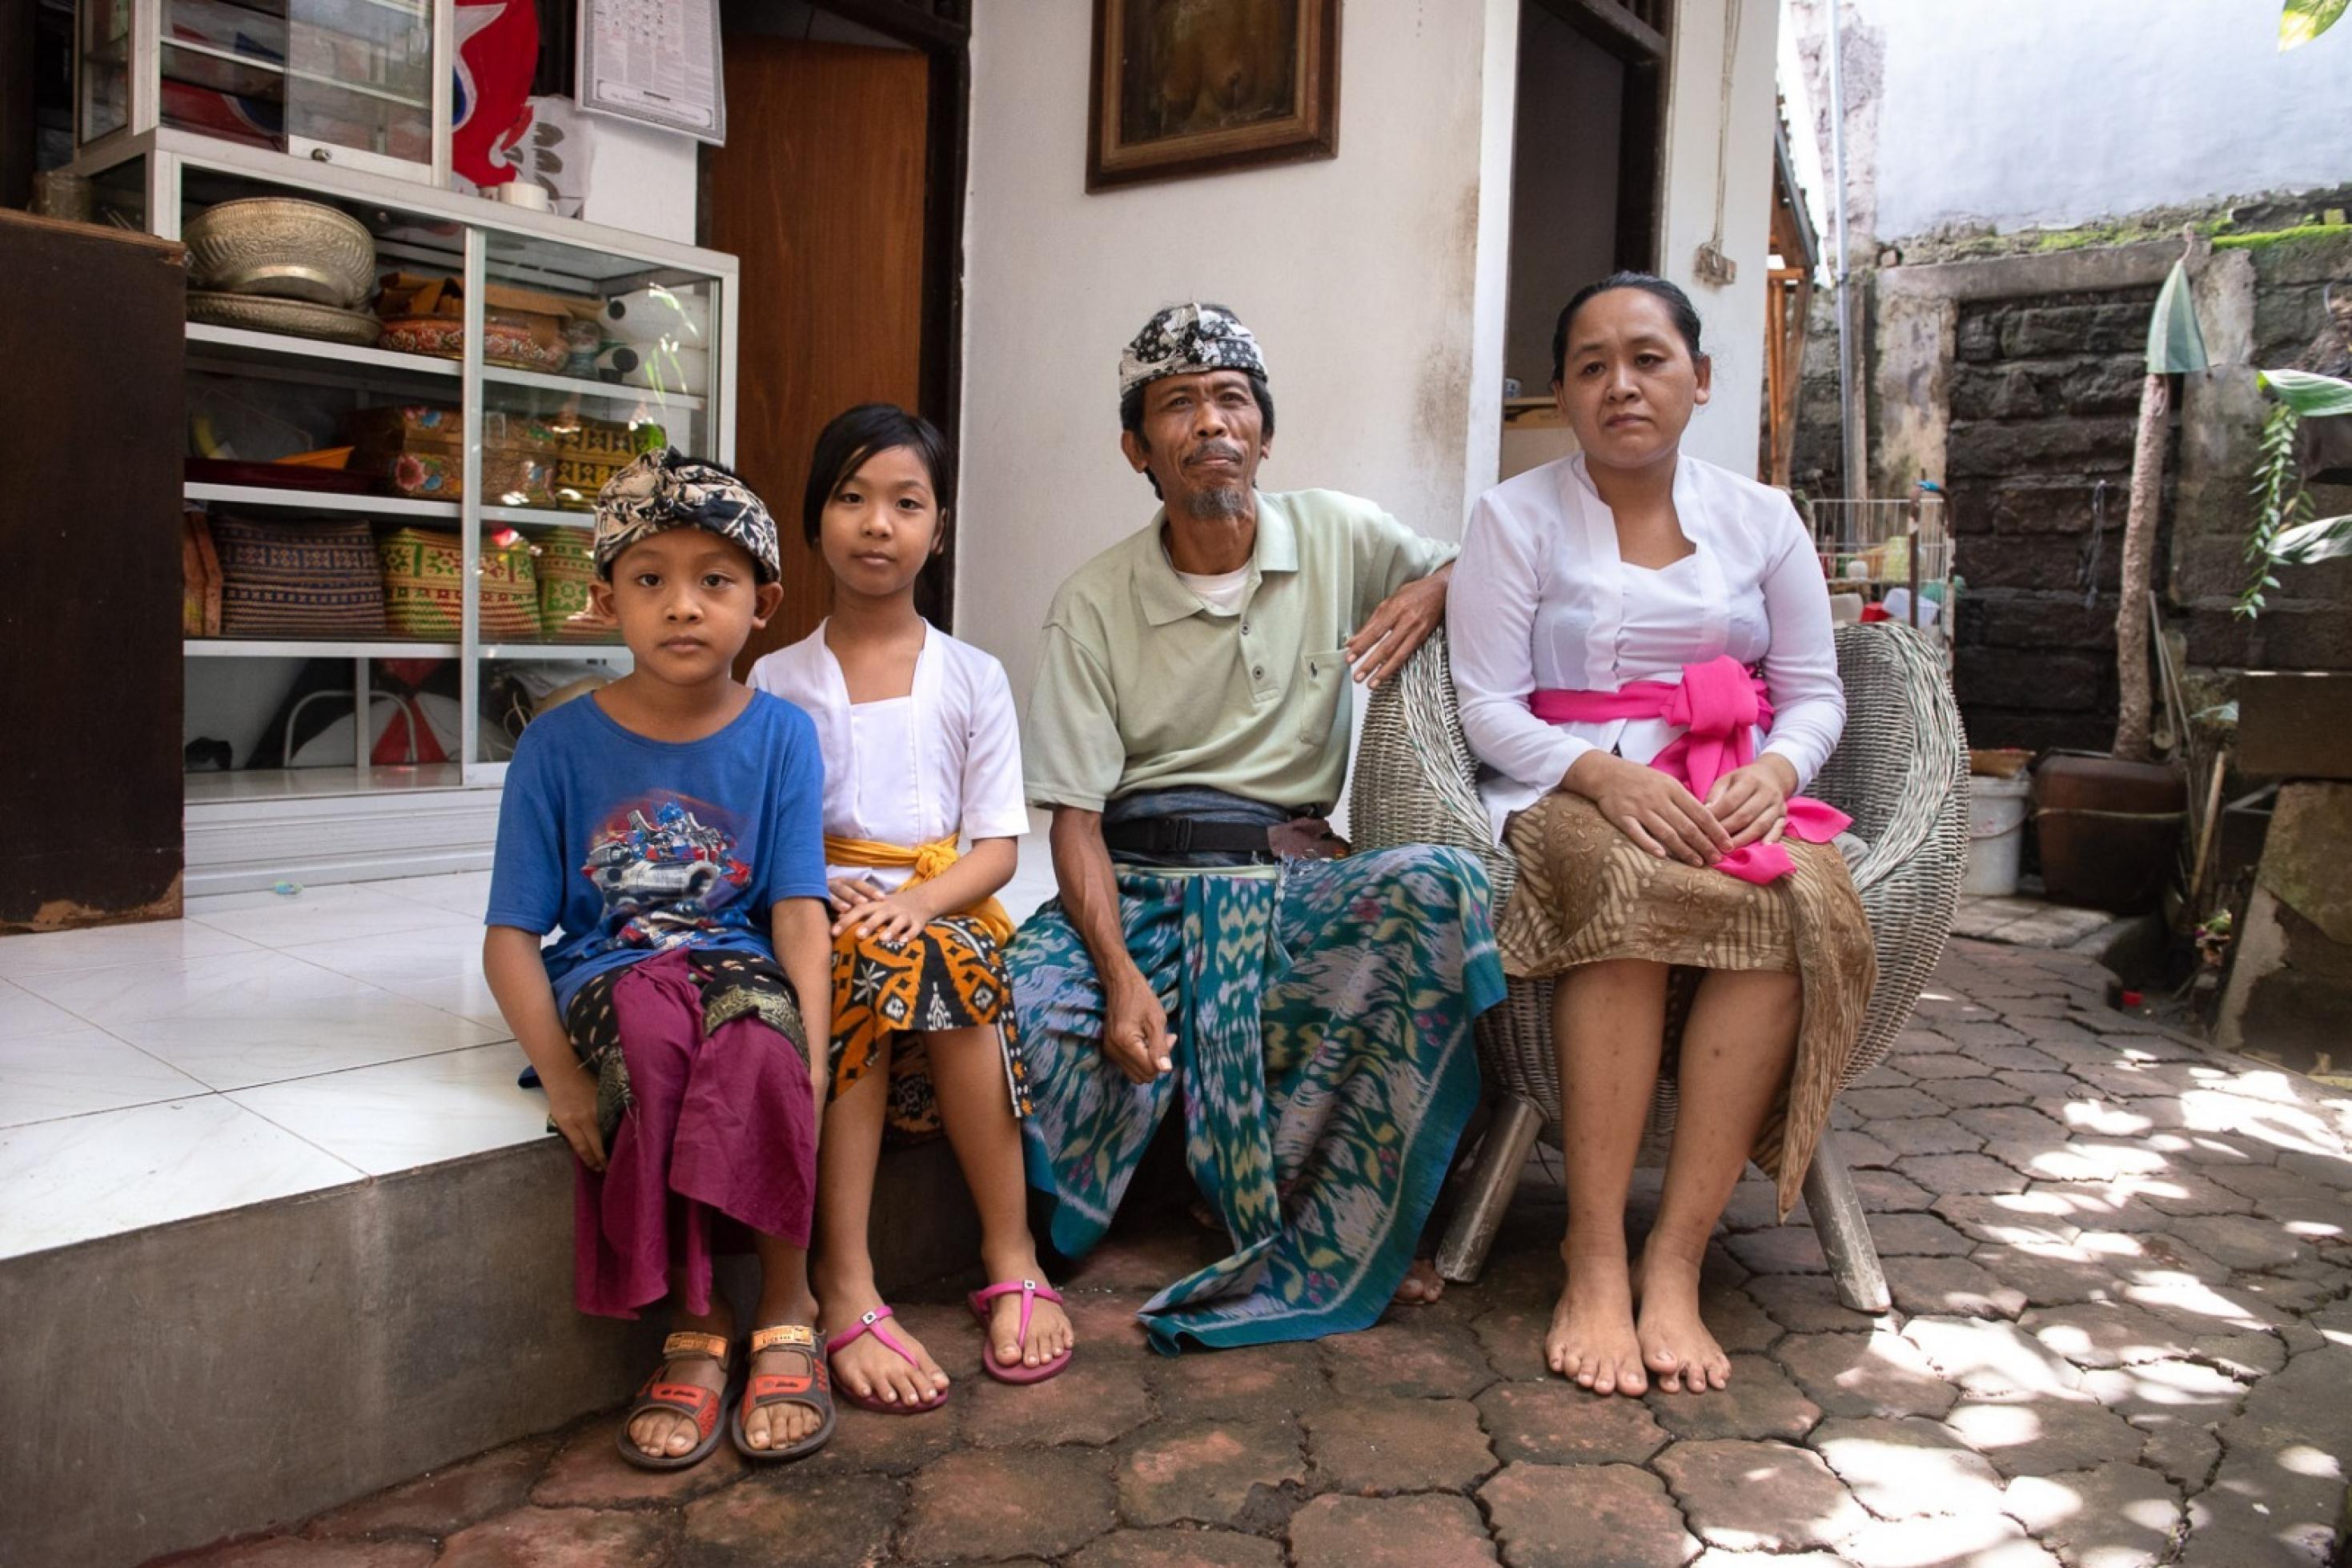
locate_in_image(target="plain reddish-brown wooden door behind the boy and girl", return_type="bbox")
[708,33,931,672]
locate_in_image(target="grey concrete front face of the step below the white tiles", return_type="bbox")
[0,1138,978,1568]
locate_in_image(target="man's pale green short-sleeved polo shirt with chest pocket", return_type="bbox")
[1023,489,1456,813]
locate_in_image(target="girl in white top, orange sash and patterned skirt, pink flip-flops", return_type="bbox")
[750,402,1073,1413]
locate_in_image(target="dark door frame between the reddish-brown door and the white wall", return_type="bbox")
[812,0,971,632]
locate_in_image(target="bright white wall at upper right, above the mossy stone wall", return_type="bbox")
[1846,0,2352,238]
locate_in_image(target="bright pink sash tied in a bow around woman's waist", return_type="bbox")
[1527,653,1853,886]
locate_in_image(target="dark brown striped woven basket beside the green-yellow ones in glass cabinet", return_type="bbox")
[209,517,383,637]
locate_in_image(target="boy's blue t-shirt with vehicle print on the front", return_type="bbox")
[484,693,825,1013]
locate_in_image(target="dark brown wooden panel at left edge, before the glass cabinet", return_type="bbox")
[0,211,188,931]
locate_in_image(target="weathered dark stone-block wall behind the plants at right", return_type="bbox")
[1792,226,2352,750]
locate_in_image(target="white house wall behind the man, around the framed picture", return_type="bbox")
[957,0,1776,693]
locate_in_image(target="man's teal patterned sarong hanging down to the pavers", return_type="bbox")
[1006,846,1503,1354]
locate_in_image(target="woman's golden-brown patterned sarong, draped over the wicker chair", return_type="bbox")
[1496,790,1877,1217]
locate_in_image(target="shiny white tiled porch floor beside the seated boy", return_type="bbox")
[0,835,1051,1257]
